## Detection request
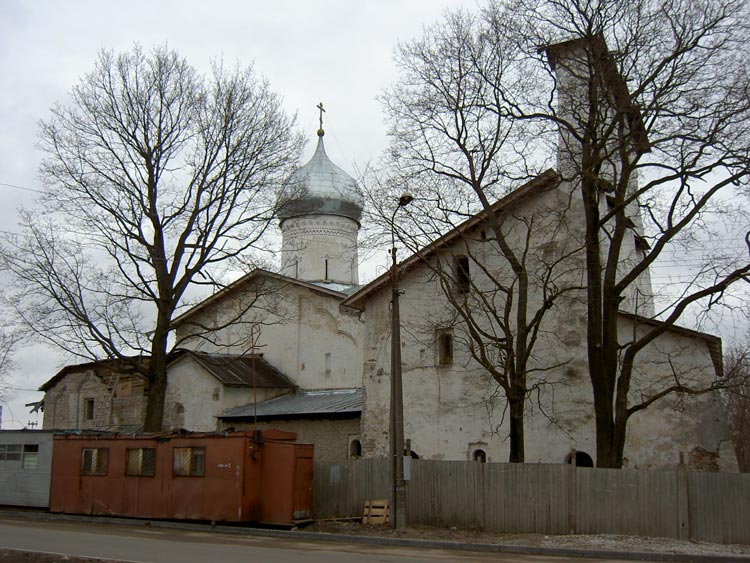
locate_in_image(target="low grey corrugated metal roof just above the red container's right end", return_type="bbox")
[219,388,362,419]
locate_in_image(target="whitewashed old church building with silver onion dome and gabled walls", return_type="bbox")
[38,38,734,470]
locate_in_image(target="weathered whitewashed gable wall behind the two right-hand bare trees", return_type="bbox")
[362,183,722,467]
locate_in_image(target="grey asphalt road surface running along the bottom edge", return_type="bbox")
[0,519,648,563]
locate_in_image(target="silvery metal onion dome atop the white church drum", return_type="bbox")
[279,128,364,224]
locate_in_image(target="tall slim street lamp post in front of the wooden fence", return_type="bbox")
[390,194,414,530]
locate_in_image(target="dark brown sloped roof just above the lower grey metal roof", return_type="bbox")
[175,350,296,389]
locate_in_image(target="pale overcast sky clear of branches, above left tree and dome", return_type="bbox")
[0,0,475,429]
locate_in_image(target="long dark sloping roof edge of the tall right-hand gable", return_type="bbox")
[343,172,560,310]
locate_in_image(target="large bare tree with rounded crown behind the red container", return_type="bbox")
[3,46,301,431]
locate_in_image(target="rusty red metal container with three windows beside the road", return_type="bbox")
[50,430,313,526]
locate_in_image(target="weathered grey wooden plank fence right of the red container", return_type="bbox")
[313,459,750,544]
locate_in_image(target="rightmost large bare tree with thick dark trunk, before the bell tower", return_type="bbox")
[485,0,750,467]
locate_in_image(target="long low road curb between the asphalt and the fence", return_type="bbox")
[0,509,750,563]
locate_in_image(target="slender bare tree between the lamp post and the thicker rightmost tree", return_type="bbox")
[378,12,580,462]
